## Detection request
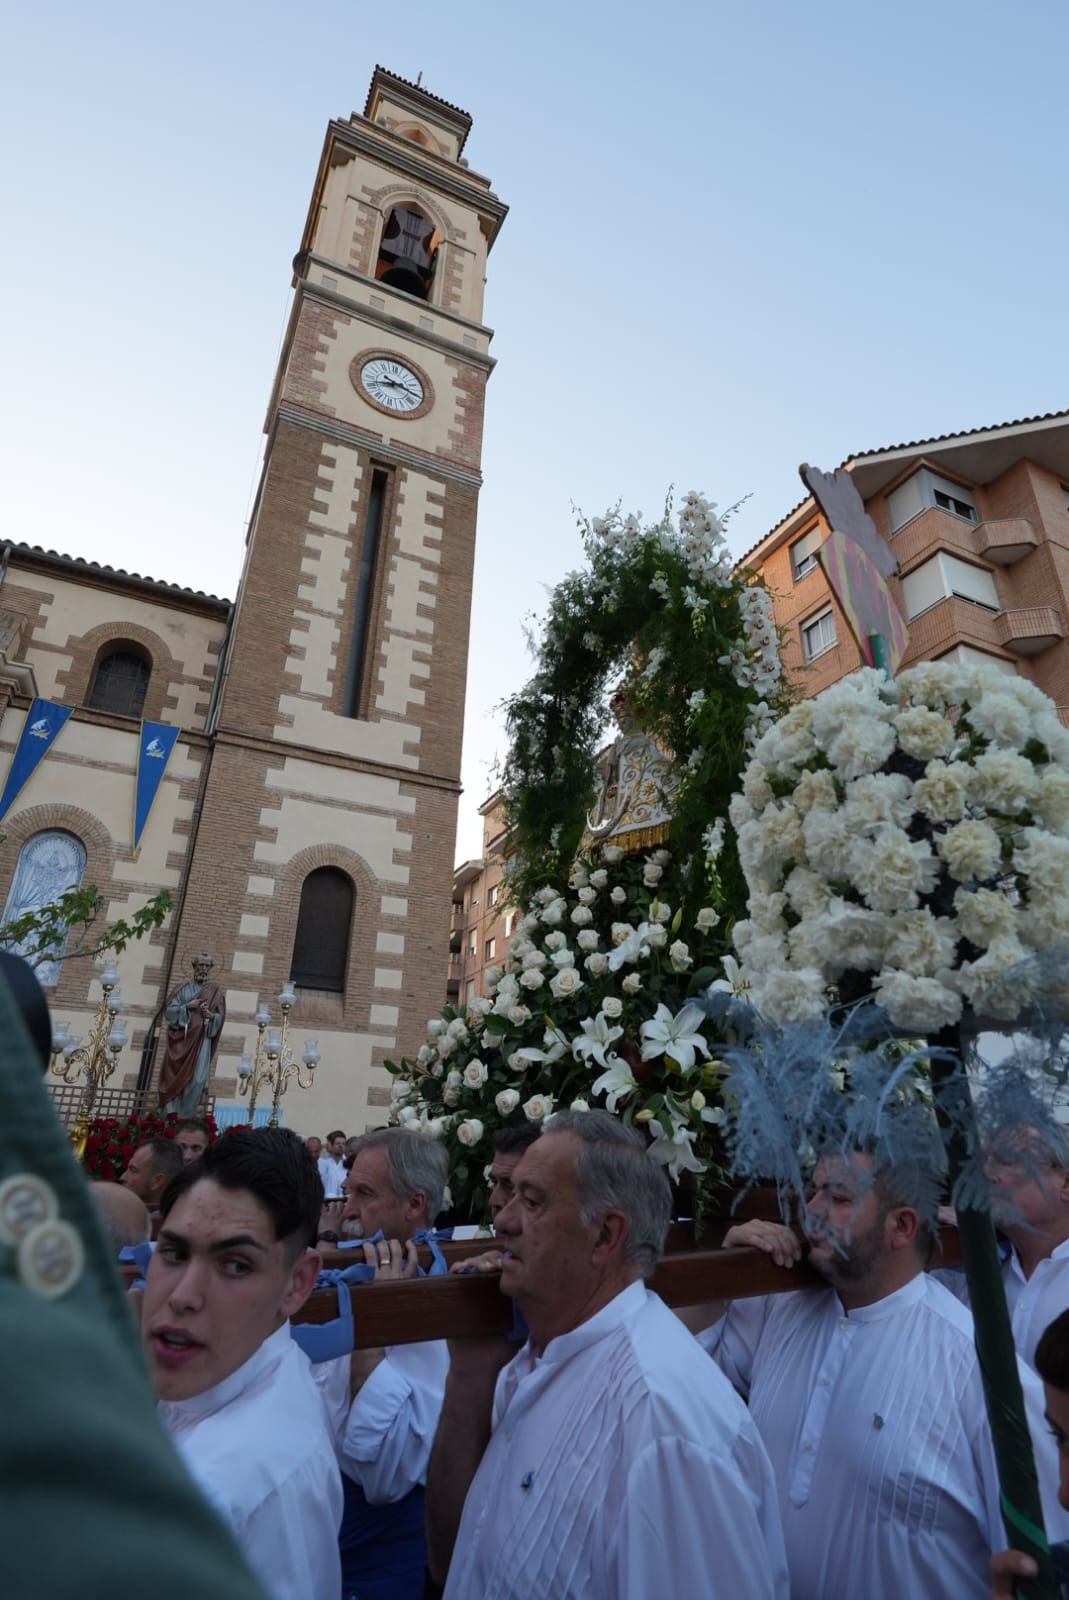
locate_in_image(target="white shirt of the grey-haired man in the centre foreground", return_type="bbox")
[445,1283,784,1600]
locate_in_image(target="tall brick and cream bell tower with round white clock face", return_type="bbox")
[170,67,506,1133]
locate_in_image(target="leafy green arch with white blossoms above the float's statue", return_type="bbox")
[502,493,783,928]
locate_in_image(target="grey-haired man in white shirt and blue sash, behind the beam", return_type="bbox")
[317,1128,450,1600]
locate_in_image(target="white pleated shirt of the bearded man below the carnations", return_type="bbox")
[701,1274,1058,1600]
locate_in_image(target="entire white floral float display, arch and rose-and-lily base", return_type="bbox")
[387,493,786,1216]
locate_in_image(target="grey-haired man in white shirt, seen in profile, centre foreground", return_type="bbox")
[427,1110,787,1600]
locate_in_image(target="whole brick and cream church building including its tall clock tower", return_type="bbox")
[0,67,506,1133]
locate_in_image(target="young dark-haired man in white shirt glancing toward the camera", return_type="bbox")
[141,1128,341,1600]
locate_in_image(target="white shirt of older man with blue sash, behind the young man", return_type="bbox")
[312,1339,450,1506]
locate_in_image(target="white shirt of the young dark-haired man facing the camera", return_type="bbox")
[158,1322,341,1600]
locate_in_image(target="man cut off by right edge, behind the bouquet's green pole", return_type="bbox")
[935,1125,1069,1368]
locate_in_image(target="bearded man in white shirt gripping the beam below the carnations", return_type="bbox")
[701,1155,1058,1600]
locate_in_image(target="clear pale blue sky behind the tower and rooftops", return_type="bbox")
[0,0,1069,854]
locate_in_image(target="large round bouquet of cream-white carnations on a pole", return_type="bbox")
[731,662,1069,1034]
